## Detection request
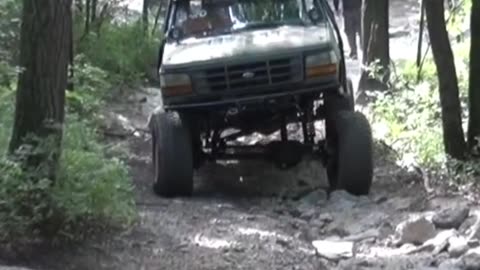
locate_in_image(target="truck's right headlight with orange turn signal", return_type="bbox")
[305,51,338,79]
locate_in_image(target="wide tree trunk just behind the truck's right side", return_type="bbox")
[359,0,390,91]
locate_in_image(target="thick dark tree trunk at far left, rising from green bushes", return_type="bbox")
[9,0,72,179]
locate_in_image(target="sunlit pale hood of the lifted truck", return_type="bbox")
[162,25,333,66]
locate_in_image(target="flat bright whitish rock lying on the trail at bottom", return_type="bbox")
[312,240,354,261]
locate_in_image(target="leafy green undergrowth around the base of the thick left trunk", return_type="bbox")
[0,61,135,241]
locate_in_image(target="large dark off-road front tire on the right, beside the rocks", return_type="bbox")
[327,110,373,195]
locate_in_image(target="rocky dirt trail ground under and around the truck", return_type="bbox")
[0,1,480,270]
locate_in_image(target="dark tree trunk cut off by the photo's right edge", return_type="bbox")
[468,0,480,153]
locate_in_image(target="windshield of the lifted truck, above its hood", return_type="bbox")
[171,0,325,38]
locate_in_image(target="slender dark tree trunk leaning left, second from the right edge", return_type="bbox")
[425,0,466,159]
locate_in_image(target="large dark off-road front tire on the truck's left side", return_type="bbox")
[150,112,193,197]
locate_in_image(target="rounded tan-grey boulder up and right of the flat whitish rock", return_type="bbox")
[395,217,436,245]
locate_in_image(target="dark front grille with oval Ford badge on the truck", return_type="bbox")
[197,58,303,92]
